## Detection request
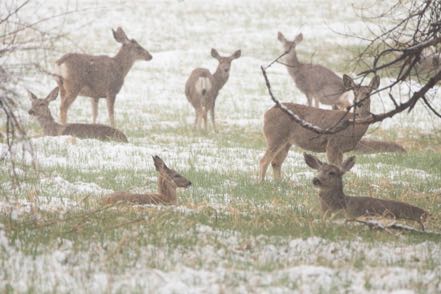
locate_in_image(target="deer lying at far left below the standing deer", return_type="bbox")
[28,87,128,143]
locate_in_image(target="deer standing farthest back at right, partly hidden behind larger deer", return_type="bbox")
[277,32,350,109]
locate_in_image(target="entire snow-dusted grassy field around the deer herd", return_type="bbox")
[0,0,441,293]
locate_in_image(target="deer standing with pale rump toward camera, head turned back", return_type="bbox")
[185,49,241,131]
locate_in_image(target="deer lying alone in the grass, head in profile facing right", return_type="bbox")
[103,155,191,204]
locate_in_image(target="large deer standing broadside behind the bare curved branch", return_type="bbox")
[259,75,380,181]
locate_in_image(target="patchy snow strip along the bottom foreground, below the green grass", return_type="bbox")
[0,225,441,293]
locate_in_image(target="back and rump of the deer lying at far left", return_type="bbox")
[60,124,128,143]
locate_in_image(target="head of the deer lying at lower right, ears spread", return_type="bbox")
[303,153,355,190]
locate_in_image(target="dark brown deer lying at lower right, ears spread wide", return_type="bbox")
[303,153,428,230]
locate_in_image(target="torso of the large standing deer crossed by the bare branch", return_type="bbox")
[263,103,369,152]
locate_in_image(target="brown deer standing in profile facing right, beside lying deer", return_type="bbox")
[56,27,152,127]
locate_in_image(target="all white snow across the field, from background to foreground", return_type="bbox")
[0,0,441,293]
